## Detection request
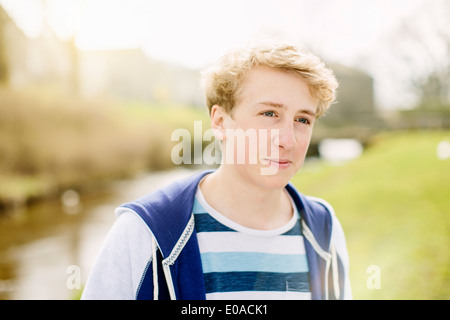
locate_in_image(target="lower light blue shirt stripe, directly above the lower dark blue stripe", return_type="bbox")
[201,252,308,273]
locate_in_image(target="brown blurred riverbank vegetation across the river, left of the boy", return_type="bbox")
[0,88,207,212]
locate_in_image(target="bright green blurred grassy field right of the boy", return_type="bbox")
[293,131,450,299]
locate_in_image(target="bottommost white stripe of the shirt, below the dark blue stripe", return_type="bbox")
[206,291,311,300]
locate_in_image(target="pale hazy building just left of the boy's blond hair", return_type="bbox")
[79,49,203,106]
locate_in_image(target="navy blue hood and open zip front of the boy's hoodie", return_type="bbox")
[82,171,351,300]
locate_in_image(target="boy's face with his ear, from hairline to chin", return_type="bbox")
[212,67,318,188]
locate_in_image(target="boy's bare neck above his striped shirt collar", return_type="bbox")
[200,166,293,230]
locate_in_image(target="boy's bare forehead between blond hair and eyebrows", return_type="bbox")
[236,67,319,112]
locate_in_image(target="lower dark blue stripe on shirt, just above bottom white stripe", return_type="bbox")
[204,272,310,293]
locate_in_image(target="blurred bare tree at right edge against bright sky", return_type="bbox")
[390,0,450,110]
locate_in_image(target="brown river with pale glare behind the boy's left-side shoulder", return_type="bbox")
[0,169,199,300]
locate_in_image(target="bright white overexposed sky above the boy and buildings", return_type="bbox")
[0,0,444,109]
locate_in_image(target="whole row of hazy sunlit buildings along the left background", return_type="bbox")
[0,6,203,105]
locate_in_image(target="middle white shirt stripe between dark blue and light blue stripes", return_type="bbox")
[197,232,305,254]
